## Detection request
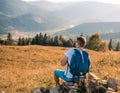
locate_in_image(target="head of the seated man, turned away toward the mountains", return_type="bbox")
[75,36,86,48]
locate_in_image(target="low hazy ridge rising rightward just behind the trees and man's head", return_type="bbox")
[54,22,120,39]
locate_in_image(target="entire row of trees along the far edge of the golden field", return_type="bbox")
[0,33,120,51]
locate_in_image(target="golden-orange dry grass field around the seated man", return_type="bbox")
[0,46,120,93]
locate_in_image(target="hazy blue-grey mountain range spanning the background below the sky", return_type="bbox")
[0,0,120,39]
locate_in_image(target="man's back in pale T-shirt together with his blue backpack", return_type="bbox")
[64,48,90,78]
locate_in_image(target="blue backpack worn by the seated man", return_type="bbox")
[69,49,90,76]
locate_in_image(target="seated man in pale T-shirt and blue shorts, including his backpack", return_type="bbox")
[54,36,90,85]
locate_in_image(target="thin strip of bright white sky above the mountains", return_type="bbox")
[22,0,120,4]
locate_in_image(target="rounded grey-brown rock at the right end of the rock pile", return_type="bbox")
[107,78,118,92]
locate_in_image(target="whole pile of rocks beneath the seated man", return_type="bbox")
[33,73,118,93]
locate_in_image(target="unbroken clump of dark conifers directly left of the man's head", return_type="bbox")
[18,33,74,47]
